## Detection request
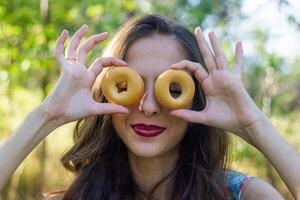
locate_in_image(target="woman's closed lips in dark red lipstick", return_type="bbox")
[131,123,166,137]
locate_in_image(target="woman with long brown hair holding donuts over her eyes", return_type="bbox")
[0,15,300,200]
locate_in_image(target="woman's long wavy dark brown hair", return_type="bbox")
[61,14,229,200]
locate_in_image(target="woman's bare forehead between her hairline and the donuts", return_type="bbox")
[125,34,187,78]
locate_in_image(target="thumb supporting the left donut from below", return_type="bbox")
[90,102,129,115]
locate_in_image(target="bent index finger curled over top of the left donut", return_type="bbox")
[88,57,127,76]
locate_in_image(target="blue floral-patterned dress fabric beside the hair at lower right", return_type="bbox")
[226,171,255,200]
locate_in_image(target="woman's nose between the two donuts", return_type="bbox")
[139,87,160,117]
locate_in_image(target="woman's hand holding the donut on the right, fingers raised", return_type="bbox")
[171,27,263,143]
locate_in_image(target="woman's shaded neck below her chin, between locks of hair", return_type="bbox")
[128,147,179,199]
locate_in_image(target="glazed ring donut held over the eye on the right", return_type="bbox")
[155,69,195,109]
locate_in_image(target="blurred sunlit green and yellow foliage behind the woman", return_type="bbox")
[0,0,300,200]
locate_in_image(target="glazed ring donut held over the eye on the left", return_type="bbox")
[101,67,144,106]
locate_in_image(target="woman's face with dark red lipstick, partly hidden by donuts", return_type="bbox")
[112,34,191,158]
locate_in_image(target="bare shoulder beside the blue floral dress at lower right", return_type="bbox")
[241,178,284,200]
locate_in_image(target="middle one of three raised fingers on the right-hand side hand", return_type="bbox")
[208,32,227,69]
